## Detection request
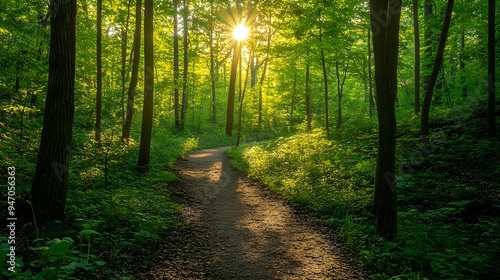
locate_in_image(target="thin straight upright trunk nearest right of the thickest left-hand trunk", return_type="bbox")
[95,0,102,145]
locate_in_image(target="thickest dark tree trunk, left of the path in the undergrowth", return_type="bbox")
[31,0,76,225]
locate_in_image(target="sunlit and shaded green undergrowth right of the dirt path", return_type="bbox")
[228,104,500,279]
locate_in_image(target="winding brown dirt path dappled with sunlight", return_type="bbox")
[141,147,365,280]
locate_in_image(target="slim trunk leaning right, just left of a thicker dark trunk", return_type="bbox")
[122,0,142,140]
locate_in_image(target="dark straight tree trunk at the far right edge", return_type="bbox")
[486,0,496,138]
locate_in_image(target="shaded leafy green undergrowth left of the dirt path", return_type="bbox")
[0,119,234,279]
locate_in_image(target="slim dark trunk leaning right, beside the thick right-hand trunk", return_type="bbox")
[420,0,455,136]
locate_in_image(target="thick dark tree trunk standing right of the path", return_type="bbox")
[370,0,402,240]
